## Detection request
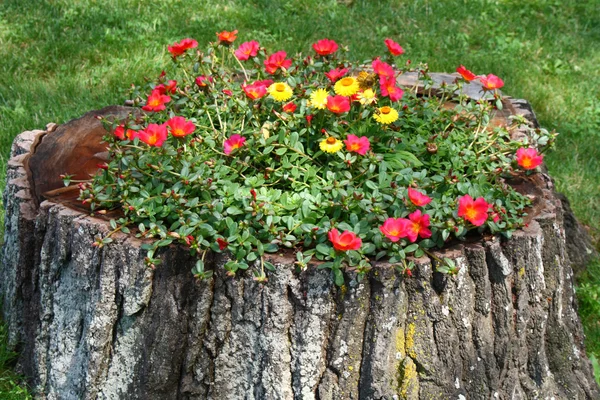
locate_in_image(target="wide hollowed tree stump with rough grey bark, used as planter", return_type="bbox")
[0,91,600,400]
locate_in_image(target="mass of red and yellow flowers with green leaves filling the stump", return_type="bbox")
[80,31,555,285]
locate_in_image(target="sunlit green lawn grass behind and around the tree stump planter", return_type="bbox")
[0,0,600,393]
